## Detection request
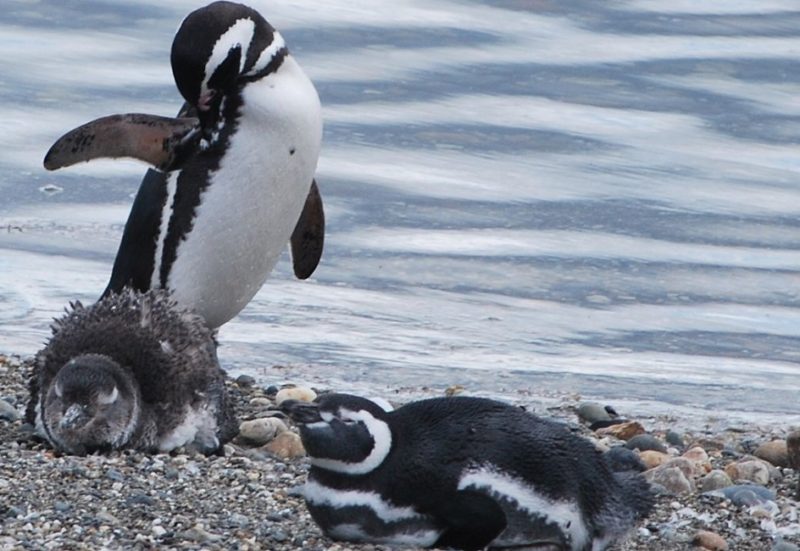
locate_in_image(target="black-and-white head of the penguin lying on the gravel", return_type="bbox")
[281,394,392,475]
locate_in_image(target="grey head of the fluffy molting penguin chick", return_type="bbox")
[42,354,139,455]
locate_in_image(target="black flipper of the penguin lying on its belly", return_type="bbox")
[434,490,506,551]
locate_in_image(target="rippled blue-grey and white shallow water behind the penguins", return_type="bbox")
[0,0,800,423]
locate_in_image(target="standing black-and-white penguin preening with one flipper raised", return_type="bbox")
[44,2,325,328]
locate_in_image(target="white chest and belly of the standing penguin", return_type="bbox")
[167,56,322,327]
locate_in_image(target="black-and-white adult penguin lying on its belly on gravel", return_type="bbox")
[281,394,653,551]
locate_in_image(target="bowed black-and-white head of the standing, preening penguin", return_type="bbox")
[171,2,285,123]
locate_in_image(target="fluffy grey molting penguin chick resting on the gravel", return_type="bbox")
[26,289,238,455]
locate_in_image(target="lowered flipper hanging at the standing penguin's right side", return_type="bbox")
[290,180,325,279]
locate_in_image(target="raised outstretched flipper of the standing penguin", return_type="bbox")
[44,113,201,170]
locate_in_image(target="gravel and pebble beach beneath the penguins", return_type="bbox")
[0,356,800,551]
